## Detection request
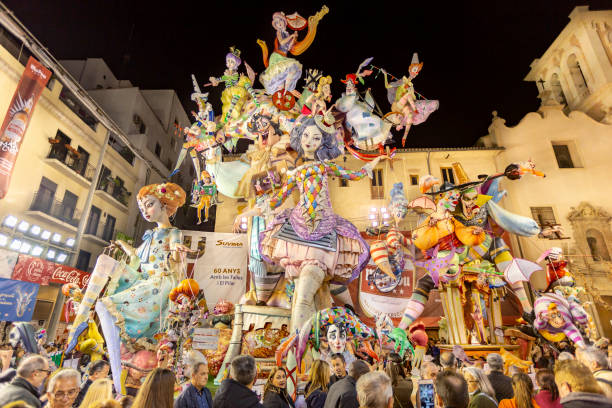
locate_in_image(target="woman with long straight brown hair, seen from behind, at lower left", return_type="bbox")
[132,368,176,408]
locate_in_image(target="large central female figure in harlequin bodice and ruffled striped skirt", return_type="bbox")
[259,116,384,332]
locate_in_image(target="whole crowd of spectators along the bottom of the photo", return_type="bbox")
[0,346,612,408]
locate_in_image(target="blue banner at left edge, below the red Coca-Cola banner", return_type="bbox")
[0,278,39,322]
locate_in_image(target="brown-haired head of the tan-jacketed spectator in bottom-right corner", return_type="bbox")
[555,360,603,398]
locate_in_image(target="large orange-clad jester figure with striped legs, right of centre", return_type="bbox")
[400,163,540,328]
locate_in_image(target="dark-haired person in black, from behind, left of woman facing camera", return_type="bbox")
[213,355,262,408]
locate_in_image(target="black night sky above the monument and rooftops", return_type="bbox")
[5,0,610,147]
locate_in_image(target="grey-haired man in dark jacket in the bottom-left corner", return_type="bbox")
[0,355,49,408]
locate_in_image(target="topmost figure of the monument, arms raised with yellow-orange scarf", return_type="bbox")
[257,6,329,110]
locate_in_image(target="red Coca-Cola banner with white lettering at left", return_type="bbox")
[12,255,90,288]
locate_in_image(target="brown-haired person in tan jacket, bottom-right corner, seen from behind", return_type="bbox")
[555,360,612,408]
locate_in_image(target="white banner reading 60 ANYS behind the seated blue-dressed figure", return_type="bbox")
[183,231,248,309]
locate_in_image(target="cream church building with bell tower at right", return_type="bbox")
[478,6,612,337]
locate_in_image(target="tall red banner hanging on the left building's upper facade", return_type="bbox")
[0,57,51,199]
